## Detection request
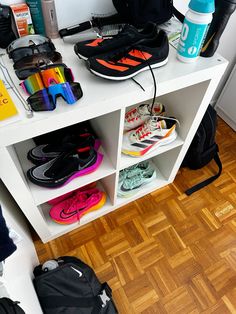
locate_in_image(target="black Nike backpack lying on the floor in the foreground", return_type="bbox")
[34,256,118,314]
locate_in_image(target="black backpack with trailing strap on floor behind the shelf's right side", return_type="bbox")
[182,105,222,195]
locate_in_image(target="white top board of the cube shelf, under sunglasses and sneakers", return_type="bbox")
[0,39,227,146]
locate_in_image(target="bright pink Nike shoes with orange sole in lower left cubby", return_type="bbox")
[49,184,106,224]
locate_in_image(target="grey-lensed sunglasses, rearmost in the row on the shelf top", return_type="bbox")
[9,41,56,62]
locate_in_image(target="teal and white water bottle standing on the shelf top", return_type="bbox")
[177,0,215,62]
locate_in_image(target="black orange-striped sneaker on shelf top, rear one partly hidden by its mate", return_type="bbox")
[74,22,157,60]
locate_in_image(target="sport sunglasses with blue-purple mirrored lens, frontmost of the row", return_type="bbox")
[27,82,83,111]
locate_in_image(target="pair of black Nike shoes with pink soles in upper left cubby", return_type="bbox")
[27,124,103,188]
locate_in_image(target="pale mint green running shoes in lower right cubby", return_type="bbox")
[118,161,156,197]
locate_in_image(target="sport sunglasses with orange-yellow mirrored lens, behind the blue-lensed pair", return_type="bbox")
[20,64,74,95]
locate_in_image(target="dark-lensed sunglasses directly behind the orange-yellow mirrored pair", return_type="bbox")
[14,51,62,80]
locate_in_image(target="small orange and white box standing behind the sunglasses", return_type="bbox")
[11,3,35,37]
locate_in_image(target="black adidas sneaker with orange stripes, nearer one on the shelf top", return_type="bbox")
[86,30,169,80]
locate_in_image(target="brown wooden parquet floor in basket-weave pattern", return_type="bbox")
[34,119,236,314]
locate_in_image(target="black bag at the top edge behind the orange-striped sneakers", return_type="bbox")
[112,0,173,27]
